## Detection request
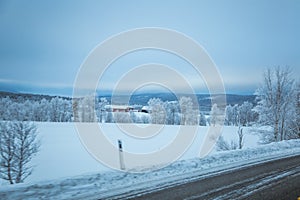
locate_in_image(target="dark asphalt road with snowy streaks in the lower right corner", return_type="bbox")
[123,156,300,200]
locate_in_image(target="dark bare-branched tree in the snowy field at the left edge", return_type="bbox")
[0,122,39,184]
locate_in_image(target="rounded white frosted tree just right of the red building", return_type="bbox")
[148,98,166,124]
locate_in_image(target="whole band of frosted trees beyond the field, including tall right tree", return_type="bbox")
[0,67,300,141]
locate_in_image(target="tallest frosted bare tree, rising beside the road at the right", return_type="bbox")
[255,67,296,141]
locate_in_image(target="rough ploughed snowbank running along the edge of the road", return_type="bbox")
[0,140,300,199]
